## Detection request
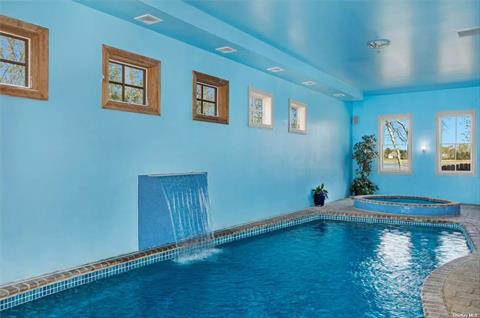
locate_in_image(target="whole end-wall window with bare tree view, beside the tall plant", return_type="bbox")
[379,115,412,173]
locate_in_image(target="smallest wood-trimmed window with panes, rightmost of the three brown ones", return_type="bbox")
[192,71,229,124]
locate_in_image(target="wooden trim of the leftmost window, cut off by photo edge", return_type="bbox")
[0,15,48,100]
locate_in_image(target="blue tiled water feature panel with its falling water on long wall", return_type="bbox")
[138,173,214,256]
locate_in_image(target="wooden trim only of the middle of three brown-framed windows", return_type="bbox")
[102,45,161,115]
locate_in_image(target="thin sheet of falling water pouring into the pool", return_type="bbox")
[161,173,217,263]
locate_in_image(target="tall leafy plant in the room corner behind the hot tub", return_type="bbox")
[350,135,378,195]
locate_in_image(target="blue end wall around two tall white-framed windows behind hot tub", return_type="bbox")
[352,87,480,204]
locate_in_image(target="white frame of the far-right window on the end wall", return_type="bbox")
[435,110,477,176]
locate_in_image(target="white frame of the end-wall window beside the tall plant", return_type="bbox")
[378,114,413,175]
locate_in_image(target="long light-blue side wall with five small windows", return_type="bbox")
[0,1,351,283]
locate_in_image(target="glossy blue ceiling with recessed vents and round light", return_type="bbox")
[78,0,480,100]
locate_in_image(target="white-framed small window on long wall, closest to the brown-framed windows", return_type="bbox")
[249,88,273,128]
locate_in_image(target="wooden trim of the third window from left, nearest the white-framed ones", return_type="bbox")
[192,71,229,125]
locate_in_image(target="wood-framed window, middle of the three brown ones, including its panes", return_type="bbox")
[102,45,160,115]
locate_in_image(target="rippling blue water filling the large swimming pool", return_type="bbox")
[1,221,469,318]
